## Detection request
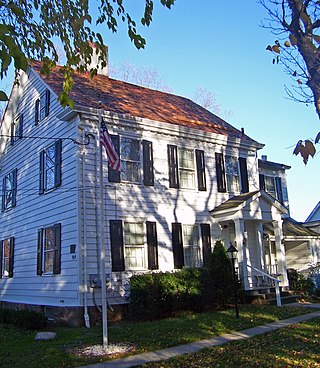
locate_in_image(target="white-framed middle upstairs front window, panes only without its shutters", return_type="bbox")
[178,147,196,189]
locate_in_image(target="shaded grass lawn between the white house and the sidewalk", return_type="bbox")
[0,306,320,368]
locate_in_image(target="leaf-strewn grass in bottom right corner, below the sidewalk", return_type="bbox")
[141,318,320,368]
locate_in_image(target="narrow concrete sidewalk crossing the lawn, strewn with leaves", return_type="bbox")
[81,303,320,368]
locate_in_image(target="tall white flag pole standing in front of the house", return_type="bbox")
[98,101,108,349]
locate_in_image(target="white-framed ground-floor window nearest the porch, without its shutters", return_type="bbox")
[182,224,202,268]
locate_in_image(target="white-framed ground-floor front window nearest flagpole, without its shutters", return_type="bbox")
[123,221,147,270]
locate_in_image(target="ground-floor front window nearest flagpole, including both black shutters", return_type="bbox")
[110,220,159,272]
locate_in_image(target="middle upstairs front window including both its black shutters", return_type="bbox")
[168,145,206,191]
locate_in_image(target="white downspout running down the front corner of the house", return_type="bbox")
[79,125,90,328]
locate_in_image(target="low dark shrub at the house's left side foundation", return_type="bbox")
[0,309,46,330]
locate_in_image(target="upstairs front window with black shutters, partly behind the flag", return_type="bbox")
[108,135,154,186]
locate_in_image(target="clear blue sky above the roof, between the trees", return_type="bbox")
[100,0,320,221]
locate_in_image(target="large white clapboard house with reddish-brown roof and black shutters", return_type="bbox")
[0,51,310,324]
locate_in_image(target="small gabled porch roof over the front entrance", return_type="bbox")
[210,190,288,221]
